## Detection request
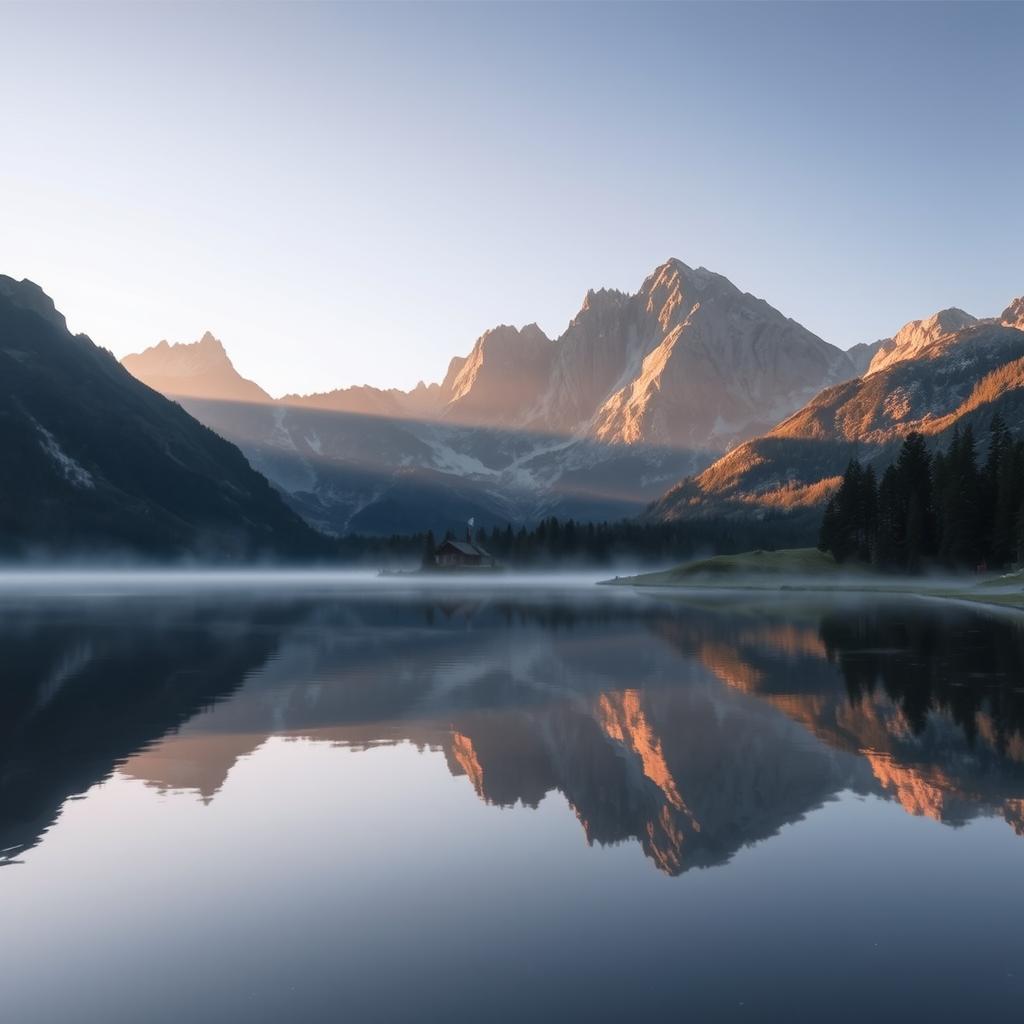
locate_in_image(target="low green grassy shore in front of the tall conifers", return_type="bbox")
[602,548,1024,608]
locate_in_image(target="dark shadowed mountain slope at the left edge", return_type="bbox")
[0,276,327,558]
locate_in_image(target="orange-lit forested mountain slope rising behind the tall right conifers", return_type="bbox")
[647,299,1024,524]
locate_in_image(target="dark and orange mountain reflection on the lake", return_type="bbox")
[6,592,1024,876]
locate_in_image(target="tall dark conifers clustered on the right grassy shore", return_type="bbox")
[818,413,1024,572]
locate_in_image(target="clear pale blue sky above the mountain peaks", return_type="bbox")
[0,3,1024,394]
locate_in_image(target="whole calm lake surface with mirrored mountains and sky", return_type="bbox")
[0,582,1024,1024]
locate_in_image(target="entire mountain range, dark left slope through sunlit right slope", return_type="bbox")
[0,260,1024,559]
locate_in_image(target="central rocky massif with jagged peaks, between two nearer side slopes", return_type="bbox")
[124,259,858,534]
